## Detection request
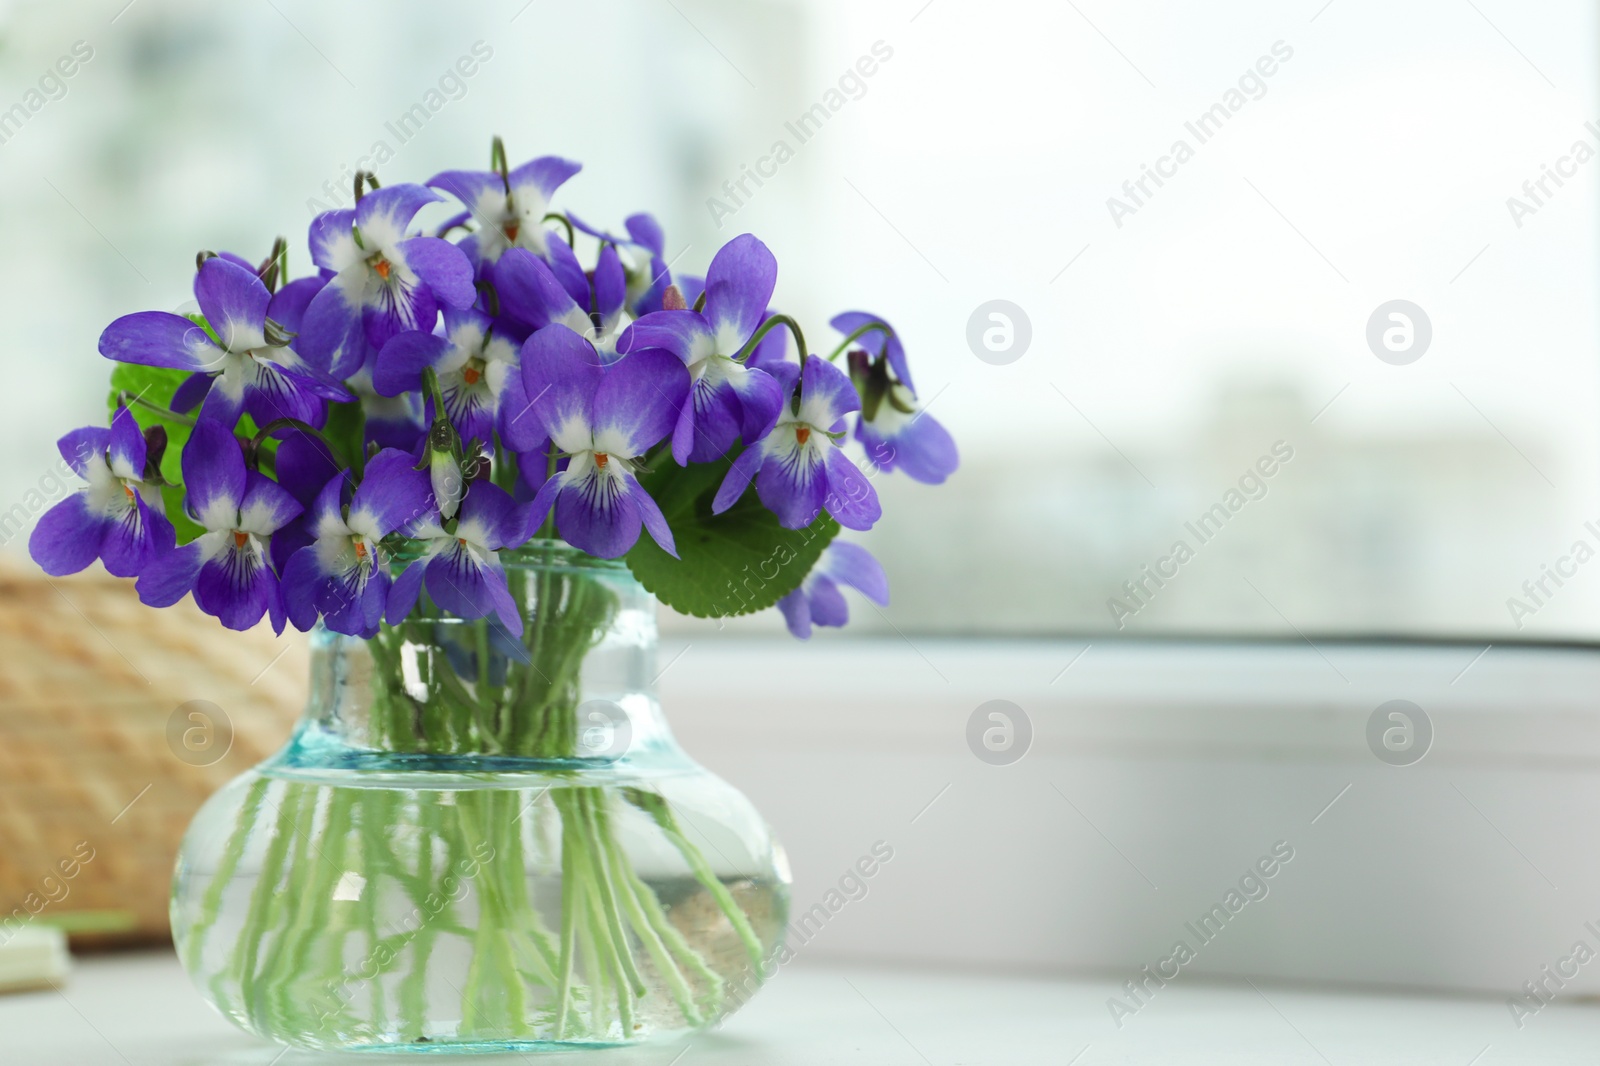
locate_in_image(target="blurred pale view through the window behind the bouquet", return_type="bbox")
[0,0,1600,639]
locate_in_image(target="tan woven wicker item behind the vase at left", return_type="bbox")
[0,565,307,948]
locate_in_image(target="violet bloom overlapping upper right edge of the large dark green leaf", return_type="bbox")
[710,355,883,530]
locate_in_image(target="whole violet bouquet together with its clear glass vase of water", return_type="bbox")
[30,139,957,1050]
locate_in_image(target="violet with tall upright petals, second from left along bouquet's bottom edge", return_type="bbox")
[134,421,301,632]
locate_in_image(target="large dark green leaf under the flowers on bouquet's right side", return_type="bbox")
[626,455,838,618]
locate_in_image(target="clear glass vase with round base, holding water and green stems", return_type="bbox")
[171,543,789,1052]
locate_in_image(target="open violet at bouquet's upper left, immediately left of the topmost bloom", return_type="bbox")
[301,184,478,378]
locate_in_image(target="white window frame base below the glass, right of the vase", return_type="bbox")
[659,637,1600,1010]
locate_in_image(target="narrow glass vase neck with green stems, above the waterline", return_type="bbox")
[283,557,677,768]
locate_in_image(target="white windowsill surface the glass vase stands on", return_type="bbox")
[9,952,1594,1066]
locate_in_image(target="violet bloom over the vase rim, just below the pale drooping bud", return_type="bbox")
[386,480,528,637]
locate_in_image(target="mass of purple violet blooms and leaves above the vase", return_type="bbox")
[29,139,957,639]
